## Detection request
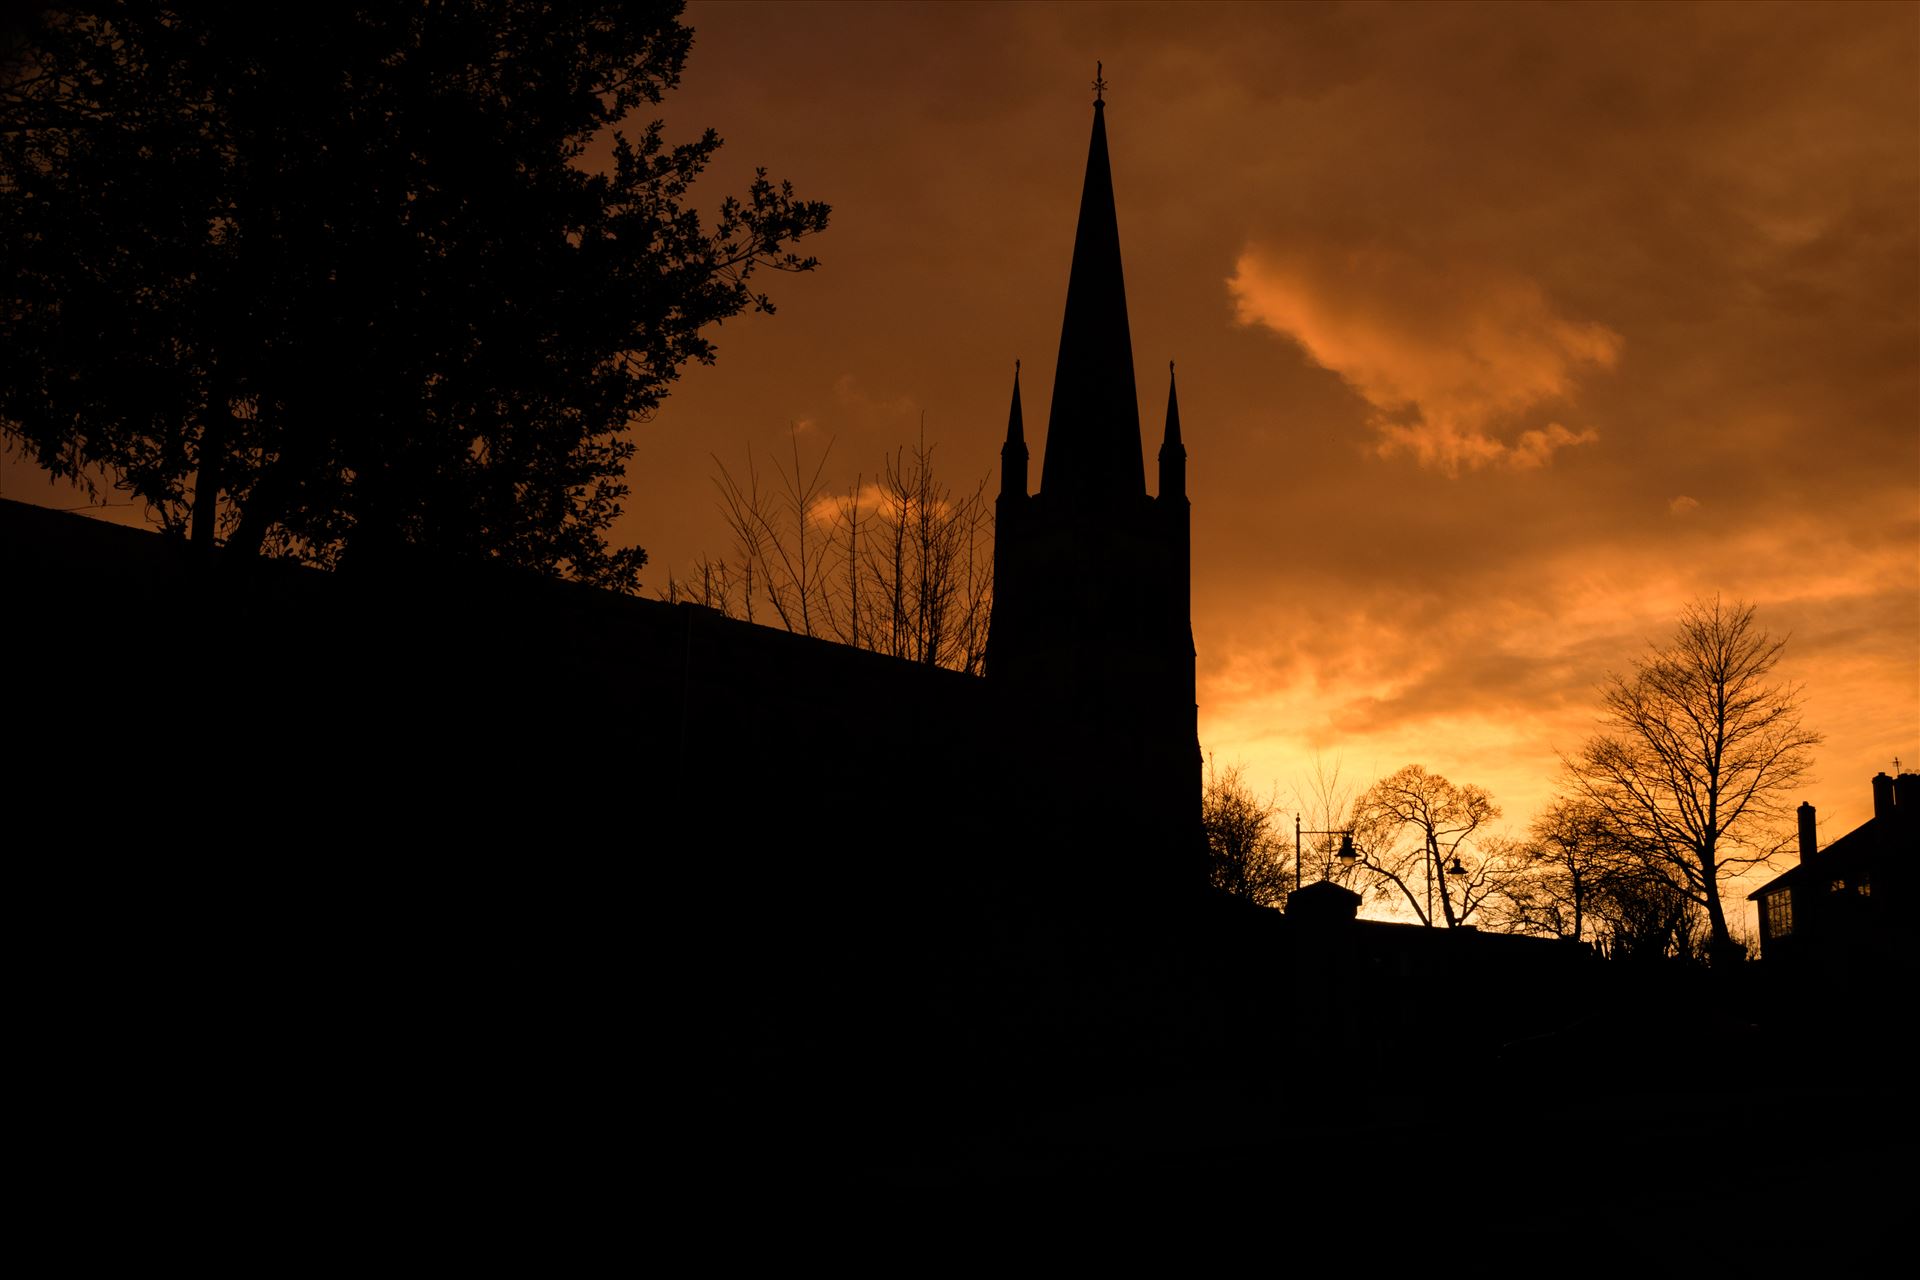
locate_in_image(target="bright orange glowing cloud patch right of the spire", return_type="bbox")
[1227,246,1620,476]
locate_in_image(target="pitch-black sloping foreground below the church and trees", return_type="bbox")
[11,503,1916,1268]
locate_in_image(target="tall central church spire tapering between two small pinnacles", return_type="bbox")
[1041,67,1146,503]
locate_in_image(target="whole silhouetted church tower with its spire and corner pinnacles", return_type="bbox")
[987,72,1206,887]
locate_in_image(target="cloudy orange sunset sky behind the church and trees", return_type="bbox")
[6,4,1920,921]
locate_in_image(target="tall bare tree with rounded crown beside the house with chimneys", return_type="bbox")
[1567,597,1820,960]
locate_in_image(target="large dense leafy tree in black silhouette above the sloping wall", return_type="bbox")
[0,0,828,589]
